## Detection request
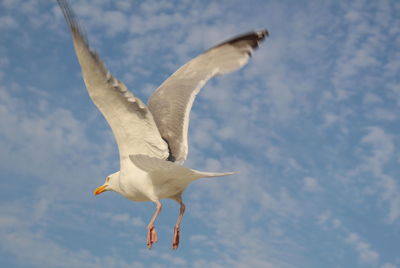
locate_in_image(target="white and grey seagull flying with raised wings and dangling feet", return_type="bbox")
[57,0,269,249]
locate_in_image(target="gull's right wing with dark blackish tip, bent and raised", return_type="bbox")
[148,30,268,163]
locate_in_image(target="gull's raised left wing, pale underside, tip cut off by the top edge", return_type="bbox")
[57,0,169,160]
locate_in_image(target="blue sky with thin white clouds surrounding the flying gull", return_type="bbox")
[0,0,400,268]
